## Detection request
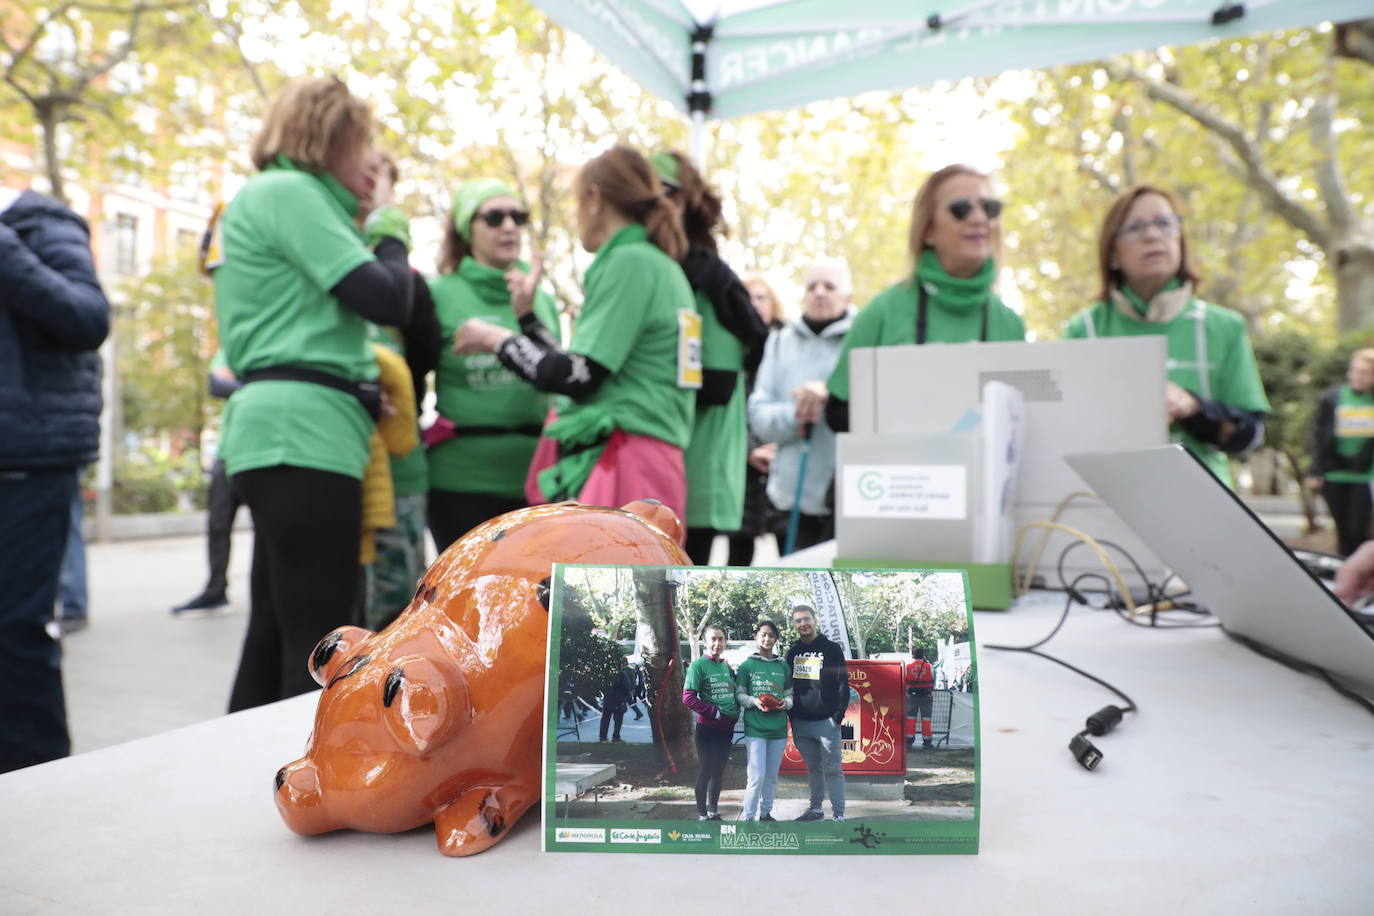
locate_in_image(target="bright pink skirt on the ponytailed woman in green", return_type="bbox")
[525,430,687,541]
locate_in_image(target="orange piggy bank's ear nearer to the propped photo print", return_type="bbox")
[382,655,471,757]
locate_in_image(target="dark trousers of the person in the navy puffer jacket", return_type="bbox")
[0,467,77,773]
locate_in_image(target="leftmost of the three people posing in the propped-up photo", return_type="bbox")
[683,623,739,821]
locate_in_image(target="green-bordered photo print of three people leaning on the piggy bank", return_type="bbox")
[545,566,978,853]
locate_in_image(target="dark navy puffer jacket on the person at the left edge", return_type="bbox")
[0,191,110,468]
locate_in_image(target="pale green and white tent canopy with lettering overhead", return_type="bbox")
[533,0,1374,125]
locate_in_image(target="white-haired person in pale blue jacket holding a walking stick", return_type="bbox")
[749,261,855,549]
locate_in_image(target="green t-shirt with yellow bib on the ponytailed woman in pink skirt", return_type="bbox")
[558,222,701,449]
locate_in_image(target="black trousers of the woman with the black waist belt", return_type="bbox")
[229,464,363,713]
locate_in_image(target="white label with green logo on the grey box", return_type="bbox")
[844,464,969,519]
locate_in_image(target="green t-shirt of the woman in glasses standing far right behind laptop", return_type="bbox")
[1063,297,1270,486]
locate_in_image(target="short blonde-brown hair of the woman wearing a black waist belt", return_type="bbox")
[249,77,372,172]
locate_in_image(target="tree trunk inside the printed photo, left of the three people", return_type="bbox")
[633,569,697,773]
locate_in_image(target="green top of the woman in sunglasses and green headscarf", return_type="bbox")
[429,258,558,499]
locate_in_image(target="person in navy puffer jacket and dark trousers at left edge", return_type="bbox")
[0,188,110,773]
